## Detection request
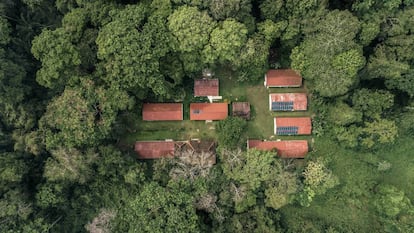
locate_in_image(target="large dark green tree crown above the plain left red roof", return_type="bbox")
[96,4,178,97]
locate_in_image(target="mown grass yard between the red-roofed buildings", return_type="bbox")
[125,75,312,143]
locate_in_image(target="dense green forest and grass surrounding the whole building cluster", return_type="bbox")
[0,0,414,233]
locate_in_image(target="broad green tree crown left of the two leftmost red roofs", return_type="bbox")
[39,79,132,149]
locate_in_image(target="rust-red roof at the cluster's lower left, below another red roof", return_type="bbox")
[135,141,174,159]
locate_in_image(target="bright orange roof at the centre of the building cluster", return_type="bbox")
[190,103,228,120]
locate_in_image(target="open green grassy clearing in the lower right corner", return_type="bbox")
[281,135,414,232]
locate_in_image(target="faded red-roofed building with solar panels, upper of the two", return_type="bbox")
[269,93,308,111]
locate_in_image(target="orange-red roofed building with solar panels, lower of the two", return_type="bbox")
[274,117,312,135]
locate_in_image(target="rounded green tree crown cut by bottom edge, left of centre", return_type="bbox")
[114,183,198,233]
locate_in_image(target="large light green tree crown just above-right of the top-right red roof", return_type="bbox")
[291,10,365,97]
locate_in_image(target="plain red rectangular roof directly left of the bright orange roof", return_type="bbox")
[142,103,183,121]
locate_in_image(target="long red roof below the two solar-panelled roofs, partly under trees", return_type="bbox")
[247,140,309,158]
